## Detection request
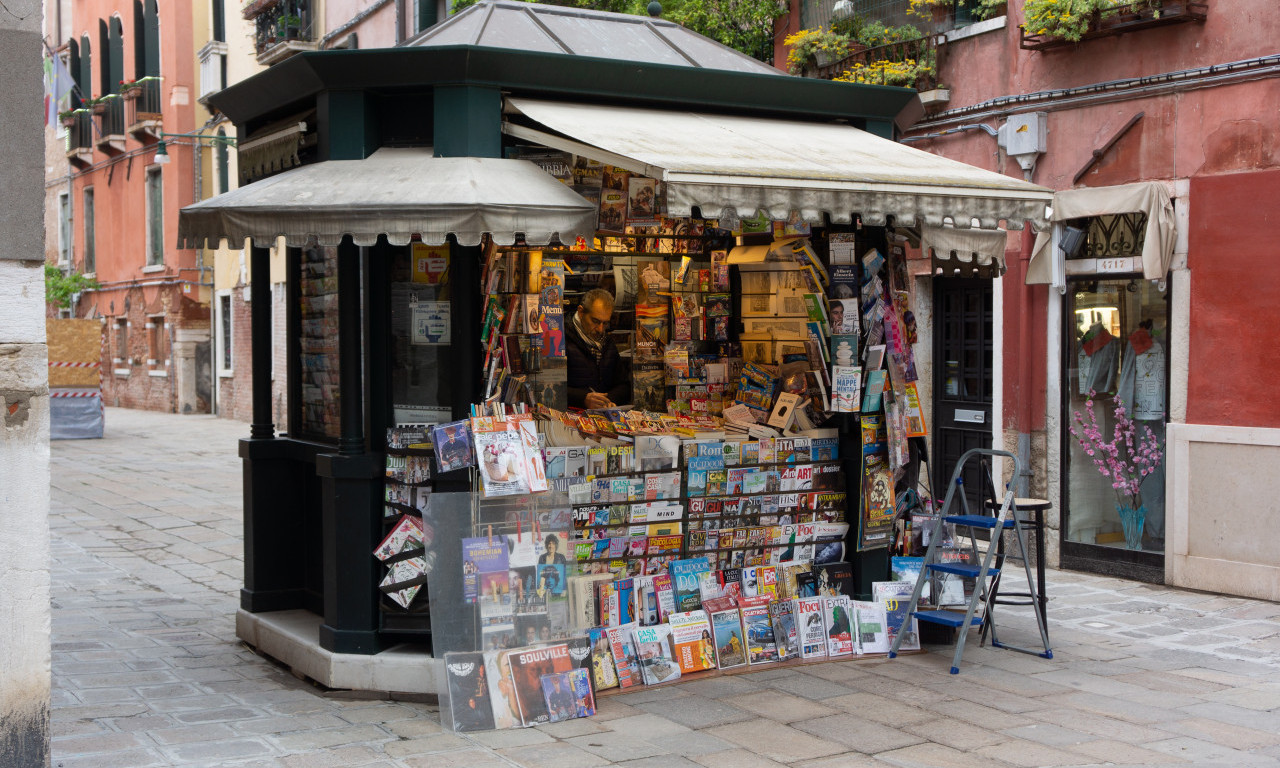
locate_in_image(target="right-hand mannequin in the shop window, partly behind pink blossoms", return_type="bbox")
[1116,320,1165,549]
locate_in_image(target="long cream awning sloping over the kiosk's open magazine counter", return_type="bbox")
[503,97,1053,229]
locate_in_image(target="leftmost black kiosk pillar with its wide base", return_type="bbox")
[239,244,302,613]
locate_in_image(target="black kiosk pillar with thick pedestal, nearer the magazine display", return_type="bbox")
[316,237,385,654]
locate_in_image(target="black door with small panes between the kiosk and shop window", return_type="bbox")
[933,278,995,512]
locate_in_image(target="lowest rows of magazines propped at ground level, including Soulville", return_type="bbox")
[442,557,919,731]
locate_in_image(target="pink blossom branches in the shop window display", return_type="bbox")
[1070,389,1164,509]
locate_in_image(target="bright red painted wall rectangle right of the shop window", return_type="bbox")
[1187,170,1280,428]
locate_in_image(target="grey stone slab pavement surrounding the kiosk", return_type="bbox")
[50,408,1280,768]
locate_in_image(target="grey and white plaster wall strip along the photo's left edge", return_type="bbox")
[0,0,50,768]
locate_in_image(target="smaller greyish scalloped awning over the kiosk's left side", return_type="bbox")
[178,148,596,248]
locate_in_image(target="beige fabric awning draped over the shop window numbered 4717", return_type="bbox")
[1027,182,1176,284]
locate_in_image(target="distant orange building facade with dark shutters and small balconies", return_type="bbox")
[46,0,211,413]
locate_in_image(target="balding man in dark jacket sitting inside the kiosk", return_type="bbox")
[564,288,631,408]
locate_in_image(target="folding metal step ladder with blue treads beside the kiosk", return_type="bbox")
[888,448,1053,675]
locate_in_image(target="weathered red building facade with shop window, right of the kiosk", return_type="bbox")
[788,0,1280,599]
